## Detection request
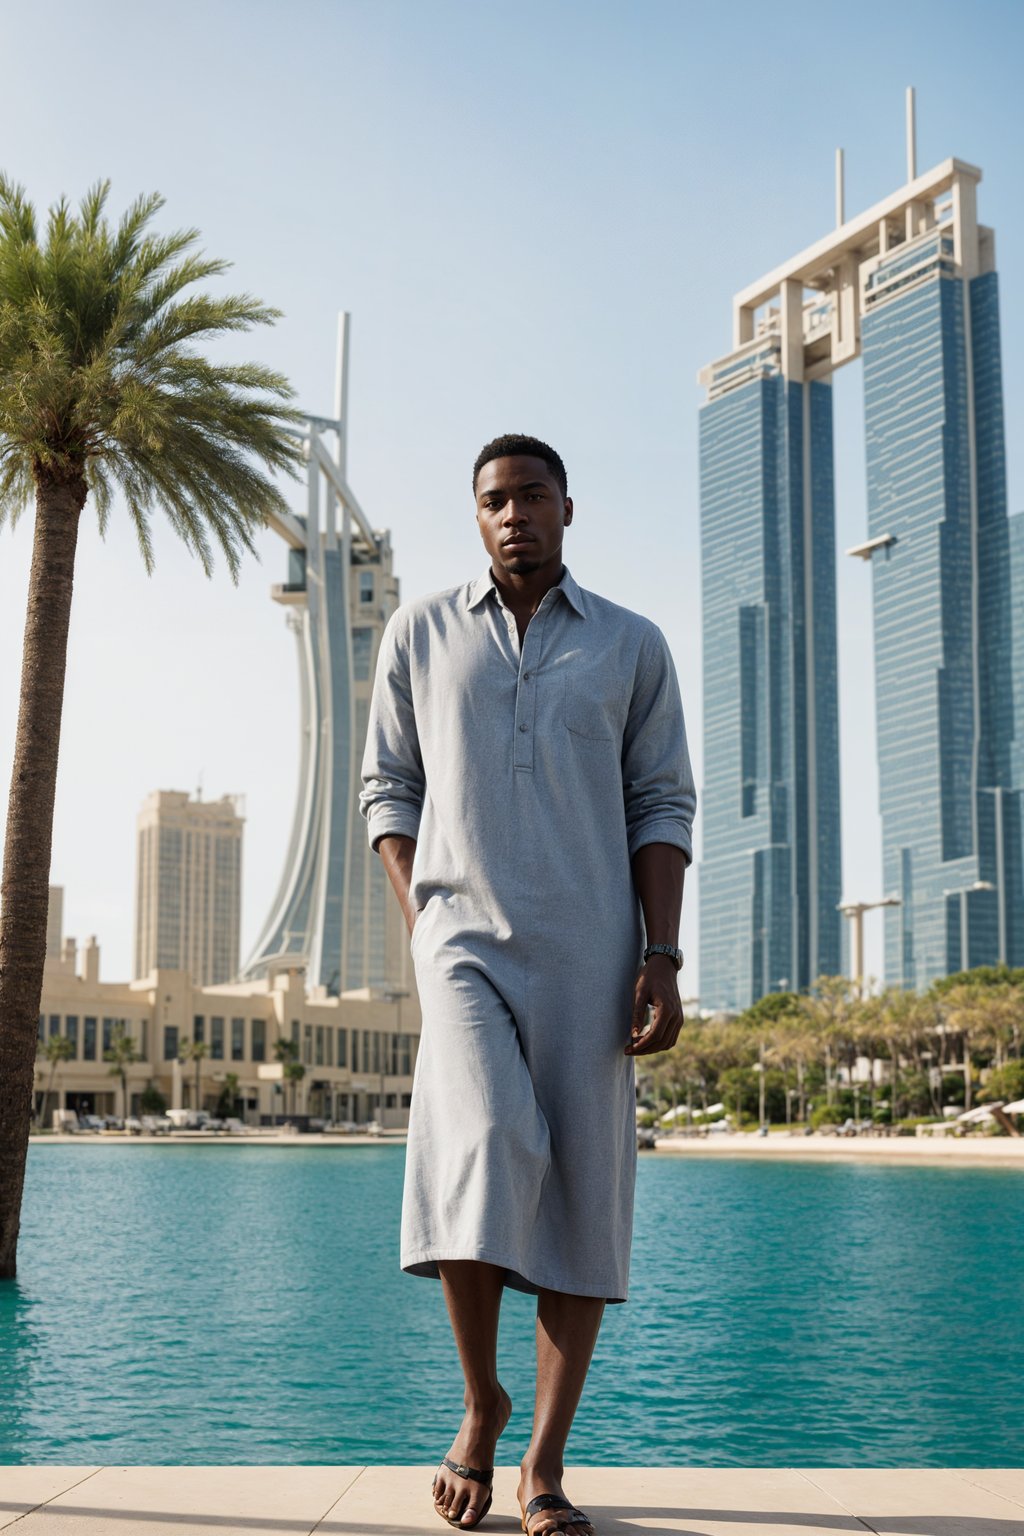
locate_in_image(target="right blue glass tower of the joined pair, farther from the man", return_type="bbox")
[861,201,1024,988]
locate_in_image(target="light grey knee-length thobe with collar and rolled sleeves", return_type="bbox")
[359,570,695,1301]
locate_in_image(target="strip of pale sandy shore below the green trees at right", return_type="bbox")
[652,1132,1024,1169]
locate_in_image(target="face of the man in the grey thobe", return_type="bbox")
[476,453,573,576]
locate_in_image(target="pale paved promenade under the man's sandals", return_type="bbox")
[0,1467,1024,1536]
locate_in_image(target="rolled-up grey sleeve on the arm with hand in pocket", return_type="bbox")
[359,610,425,851]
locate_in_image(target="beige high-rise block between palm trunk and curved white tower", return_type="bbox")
[135,790,244,986]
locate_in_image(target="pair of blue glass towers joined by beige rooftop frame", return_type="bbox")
[700,141,1024,1009]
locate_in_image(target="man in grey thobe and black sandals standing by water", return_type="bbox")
[361,435,695,1536]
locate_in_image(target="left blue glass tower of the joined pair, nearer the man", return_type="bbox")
[700,343,840,1008]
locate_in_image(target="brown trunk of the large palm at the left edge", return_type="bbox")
[0,476,86,1279]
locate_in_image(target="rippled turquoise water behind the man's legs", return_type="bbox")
[0,1146,1024,1467]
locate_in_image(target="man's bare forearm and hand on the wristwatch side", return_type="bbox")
[625,843,686,1055]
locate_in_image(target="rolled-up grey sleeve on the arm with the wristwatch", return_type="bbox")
[622,630,697,863]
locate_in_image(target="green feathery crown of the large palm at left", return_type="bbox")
[0,175,301,581]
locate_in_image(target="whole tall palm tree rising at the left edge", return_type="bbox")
[0,175,299,1278]
